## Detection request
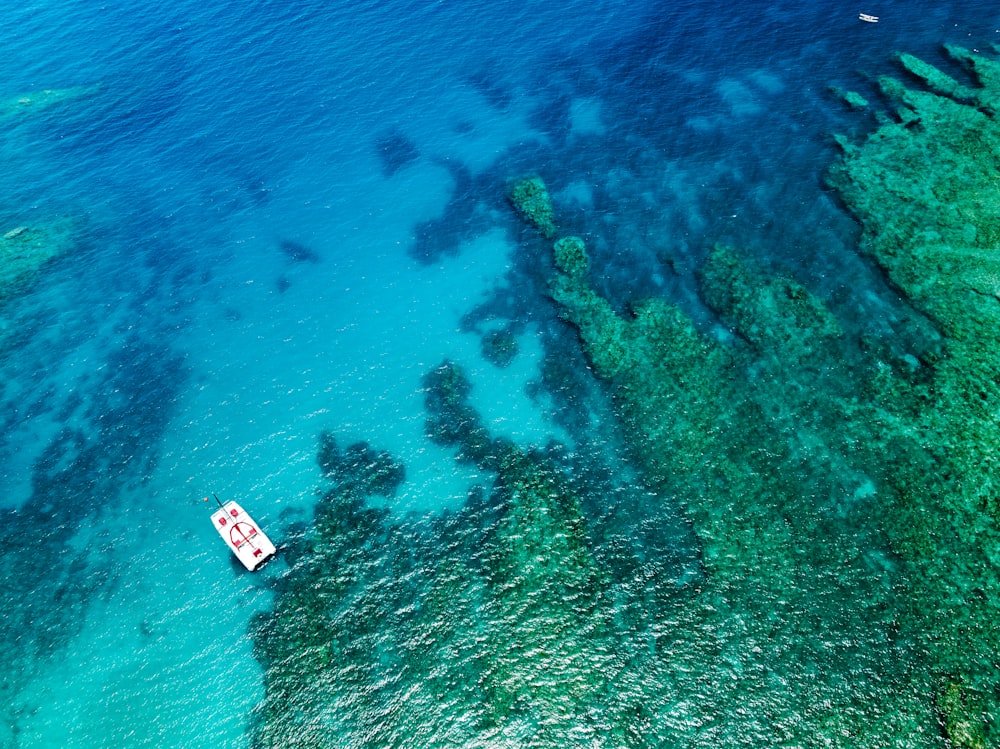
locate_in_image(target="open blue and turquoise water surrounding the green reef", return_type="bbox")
[0,0,1000,749]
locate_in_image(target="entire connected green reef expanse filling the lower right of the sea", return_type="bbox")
[255,47,1000,748]
